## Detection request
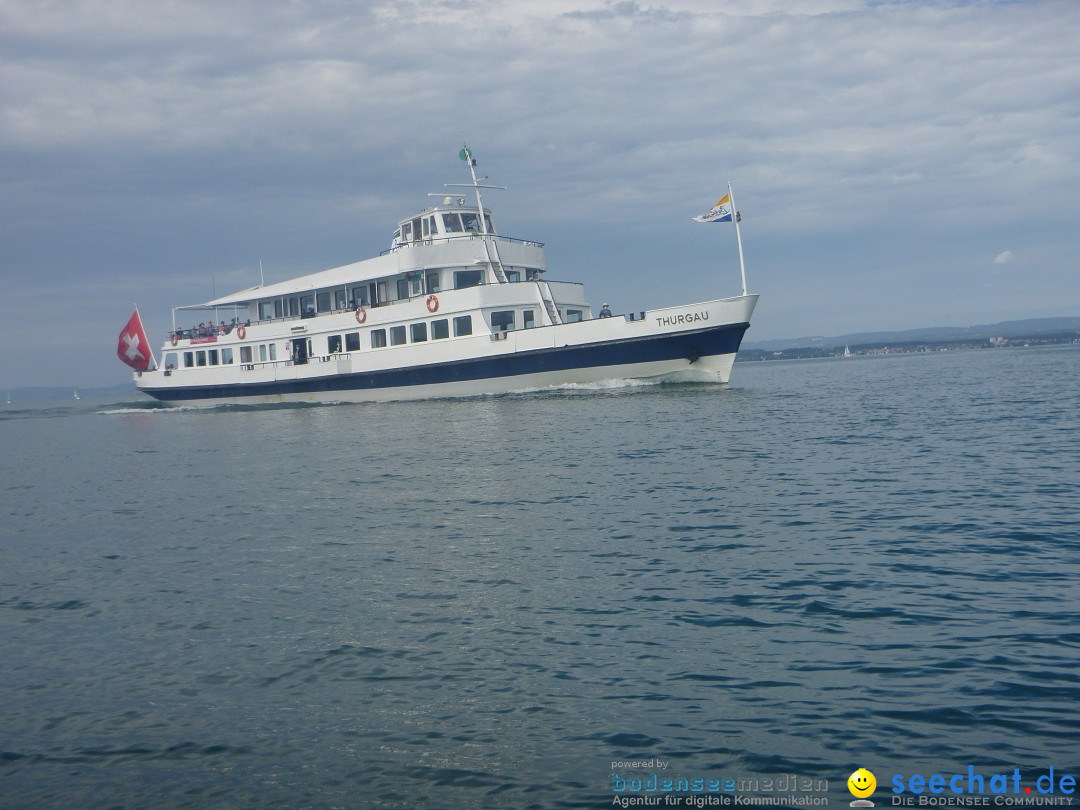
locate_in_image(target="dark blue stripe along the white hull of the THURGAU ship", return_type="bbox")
[140,323,750,402]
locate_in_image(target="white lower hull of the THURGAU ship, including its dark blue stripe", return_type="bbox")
[136,296,757,405]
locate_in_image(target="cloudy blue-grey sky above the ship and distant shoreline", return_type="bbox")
[0,0,1080,389]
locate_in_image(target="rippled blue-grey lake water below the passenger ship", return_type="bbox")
[0,347,1080,808]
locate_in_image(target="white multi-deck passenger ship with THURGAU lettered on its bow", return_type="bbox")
[126,147,757,404]
